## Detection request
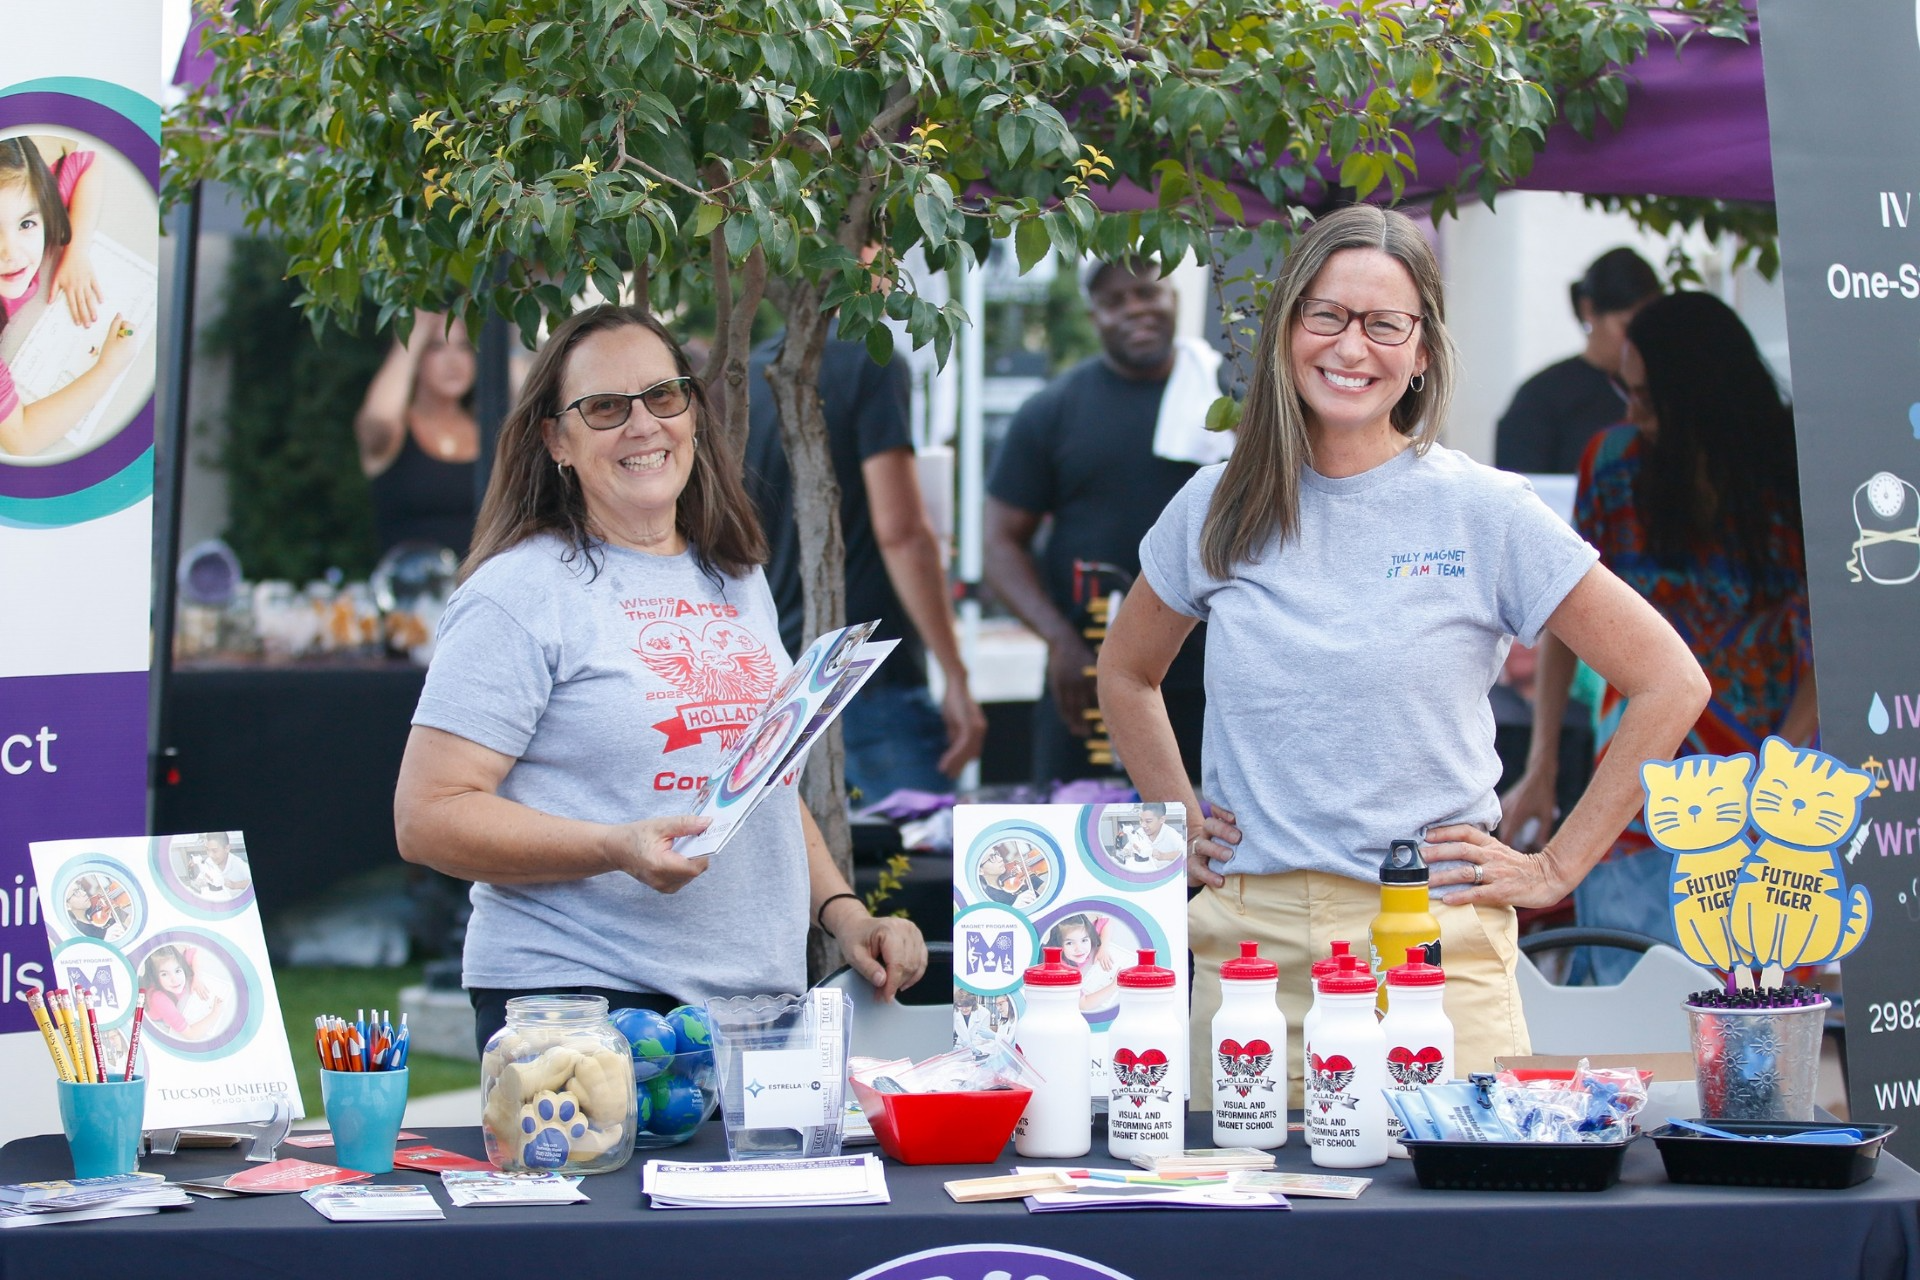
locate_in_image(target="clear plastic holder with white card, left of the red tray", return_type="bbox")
[707,988,852,1161]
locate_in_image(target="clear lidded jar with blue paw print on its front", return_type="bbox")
[480,996,639,1174]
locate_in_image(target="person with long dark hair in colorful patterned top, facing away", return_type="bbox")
[1501,294,1818,983]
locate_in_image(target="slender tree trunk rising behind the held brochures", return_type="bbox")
[766,280,852,979]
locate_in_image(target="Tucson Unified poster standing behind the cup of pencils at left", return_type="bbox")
[33,831,303,1128]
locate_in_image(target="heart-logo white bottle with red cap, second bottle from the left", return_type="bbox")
[1106,948,1187,1159]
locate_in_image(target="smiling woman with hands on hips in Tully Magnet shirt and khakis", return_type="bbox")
[1100,205,1707,1105]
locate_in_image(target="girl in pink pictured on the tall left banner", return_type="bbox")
[0,136,146,459]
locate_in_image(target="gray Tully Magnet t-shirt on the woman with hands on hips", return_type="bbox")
[1140,447,1597,879]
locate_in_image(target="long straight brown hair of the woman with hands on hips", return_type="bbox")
[1200,205,1459,578]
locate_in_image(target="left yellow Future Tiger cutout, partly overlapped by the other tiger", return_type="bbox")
[1640,754,1753,969]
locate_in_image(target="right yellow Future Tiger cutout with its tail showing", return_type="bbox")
[1732,737,1874,969]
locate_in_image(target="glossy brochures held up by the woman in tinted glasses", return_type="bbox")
[676,622,899,858]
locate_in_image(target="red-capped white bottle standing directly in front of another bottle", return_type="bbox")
[1308,956,1388,1169]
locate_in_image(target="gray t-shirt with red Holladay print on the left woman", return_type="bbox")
[413,535,808,1002]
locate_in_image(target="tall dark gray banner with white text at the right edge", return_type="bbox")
[1761,0,1920,1163]
